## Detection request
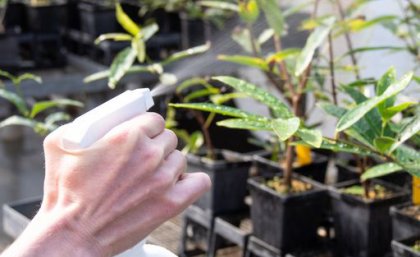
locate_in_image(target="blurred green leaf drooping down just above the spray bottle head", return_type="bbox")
[108,47,137,89]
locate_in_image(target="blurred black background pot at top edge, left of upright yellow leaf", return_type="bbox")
[78,2,118,40]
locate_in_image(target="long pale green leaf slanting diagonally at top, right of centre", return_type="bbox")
[294,17,335,77]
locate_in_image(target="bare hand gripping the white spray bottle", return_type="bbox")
[0,113,211,257]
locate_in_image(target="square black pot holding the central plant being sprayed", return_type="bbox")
[248,171,327,252]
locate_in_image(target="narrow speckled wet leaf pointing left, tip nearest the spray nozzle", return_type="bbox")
[169,103,267,120]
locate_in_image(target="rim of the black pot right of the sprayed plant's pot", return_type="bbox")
[328,179,409,206]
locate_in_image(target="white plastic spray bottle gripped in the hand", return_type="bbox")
[62,88,176,257]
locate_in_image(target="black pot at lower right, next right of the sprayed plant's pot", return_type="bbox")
[330,181,409,257]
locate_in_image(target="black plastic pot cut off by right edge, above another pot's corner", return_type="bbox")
[390,203,420,240]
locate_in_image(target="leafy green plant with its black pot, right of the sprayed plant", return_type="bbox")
[320,65,420,256]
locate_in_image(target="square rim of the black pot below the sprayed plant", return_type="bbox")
[248,173,327,202]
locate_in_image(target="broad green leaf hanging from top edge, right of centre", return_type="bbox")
[257,0,284,36]
